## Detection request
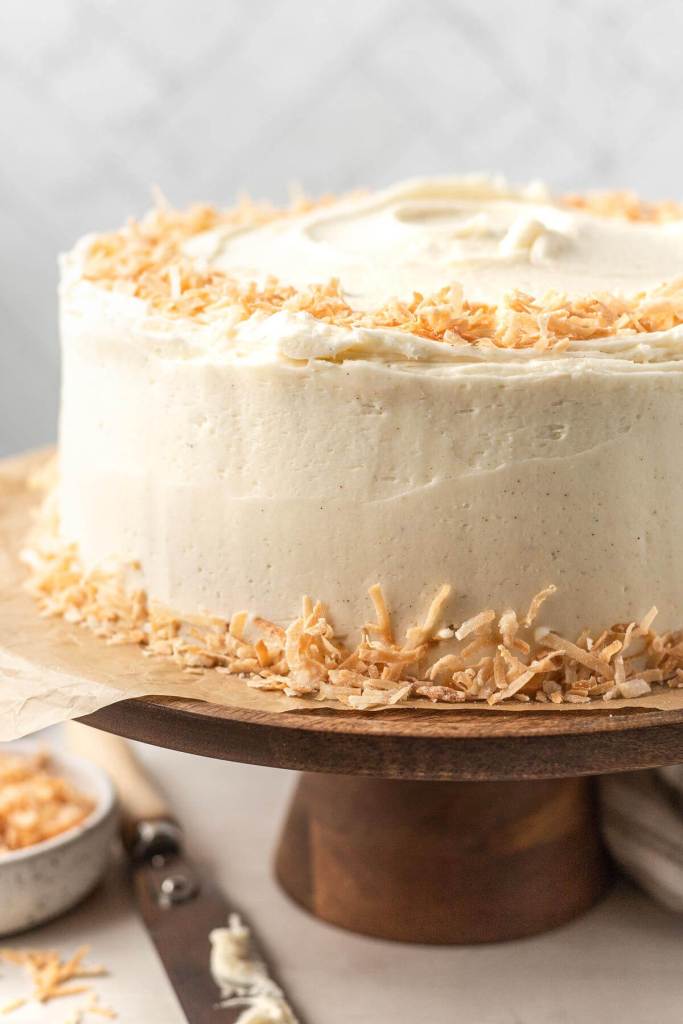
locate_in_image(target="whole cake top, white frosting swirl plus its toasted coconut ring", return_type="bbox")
[65,178,683,361]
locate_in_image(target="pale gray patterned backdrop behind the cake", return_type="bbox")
[0,0,683,454]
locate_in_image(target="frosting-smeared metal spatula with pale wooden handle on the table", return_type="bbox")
[67,722,296,1024]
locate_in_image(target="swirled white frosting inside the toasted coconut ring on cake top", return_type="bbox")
[193,178,683,309]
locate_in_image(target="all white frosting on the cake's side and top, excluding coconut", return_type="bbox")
[60,179,683,633]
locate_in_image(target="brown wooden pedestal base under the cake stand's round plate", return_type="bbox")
[275,774,608,943]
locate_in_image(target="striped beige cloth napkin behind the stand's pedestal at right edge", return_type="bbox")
[600,765,683,912]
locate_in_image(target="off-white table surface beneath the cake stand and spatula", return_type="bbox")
[0,724,683,1024]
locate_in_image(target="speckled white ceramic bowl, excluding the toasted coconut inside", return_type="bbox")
[0,743,117,936]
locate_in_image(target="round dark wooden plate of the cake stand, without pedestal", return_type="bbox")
[83,697,683,781]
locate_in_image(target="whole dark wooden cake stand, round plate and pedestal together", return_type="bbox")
[82,697,683,943]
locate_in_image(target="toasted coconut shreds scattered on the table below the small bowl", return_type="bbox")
[0,946,118,1024]
